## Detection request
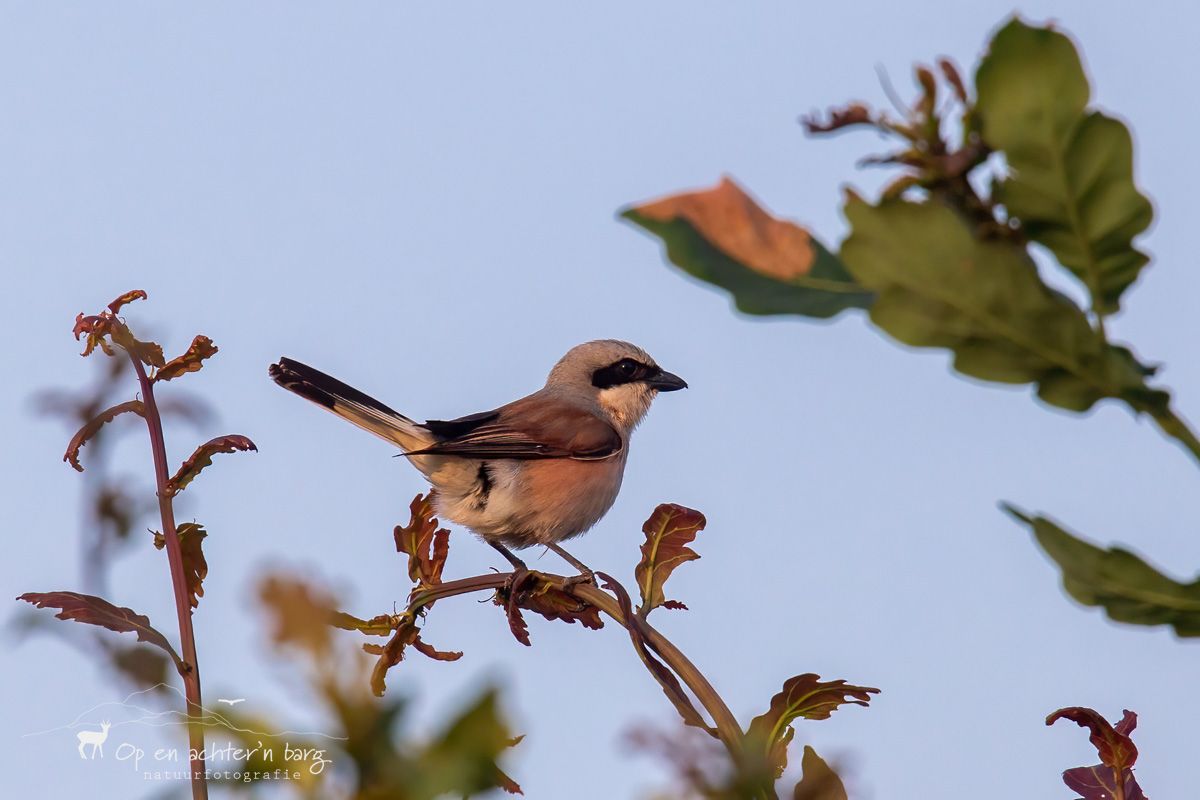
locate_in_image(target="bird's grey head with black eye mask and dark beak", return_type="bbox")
[546,339,688,431]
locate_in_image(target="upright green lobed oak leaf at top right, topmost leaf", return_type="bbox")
[976,19,1154,314]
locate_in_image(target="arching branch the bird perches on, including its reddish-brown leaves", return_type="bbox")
[343,495,878,800]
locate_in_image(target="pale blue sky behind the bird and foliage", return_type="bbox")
[0,1,1200,800]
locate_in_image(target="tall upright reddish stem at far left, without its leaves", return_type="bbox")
[130,353,209,800]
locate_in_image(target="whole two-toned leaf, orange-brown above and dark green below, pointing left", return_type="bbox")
[622,178,871,319]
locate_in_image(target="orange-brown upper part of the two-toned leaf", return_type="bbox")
[632,178,815,281]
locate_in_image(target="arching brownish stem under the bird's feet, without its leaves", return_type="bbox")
[409,572,744,763]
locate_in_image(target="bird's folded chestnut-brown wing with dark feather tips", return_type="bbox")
[408,396,624,461]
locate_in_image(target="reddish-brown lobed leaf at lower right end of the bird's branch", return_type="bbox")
[746,673,880,777]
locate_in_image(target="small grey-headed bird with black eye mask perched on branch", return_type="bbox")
[269,339,688,583]
